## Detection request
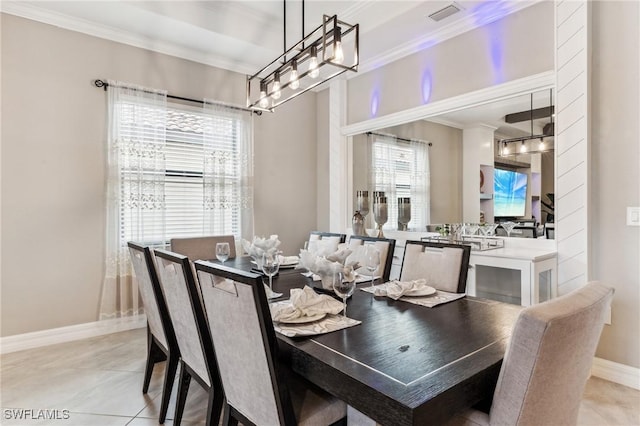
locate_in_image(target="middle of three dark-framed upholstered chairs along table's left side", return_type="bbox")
[155,250,224,426]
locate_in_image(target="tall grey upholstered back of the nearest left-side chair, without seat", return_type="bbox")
[194,261,295,425]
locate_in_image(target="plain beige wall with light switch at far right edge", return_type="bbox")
[589,1,640,368]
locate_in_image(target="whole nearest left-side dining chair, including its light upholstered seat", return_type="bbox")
[194,261,346,425]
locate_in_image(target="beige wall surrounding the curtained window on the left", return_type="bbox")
[0,14,316,336]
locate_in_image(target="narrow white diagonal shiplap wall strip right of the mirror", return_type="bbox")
[555,0,590,294]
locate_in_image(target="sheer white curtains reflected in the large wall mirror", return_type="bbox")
[369,133,431,231]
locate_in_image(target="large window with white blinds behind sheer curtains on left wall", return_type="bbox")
[119,98,252,246]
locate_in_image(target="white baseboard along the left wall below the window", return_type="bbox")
[0,314,147,354]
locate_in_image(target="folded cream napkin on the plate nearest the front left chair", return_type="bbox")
[270,286,342,322]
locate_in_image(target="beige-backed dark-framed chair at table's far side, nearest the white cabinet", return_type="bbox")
[400,240,471,293]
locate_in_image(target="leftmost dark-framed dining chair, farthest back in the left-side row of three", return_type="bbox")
[128,241,180,423]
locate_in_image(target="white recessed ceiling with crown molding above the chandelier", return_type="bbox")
[0,0,539,74]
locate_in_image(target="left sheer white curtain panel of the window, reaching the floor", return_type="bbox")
[100,81,167,319]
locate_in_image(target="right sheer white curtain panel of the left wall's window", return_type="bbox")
[203,100,254,240]
